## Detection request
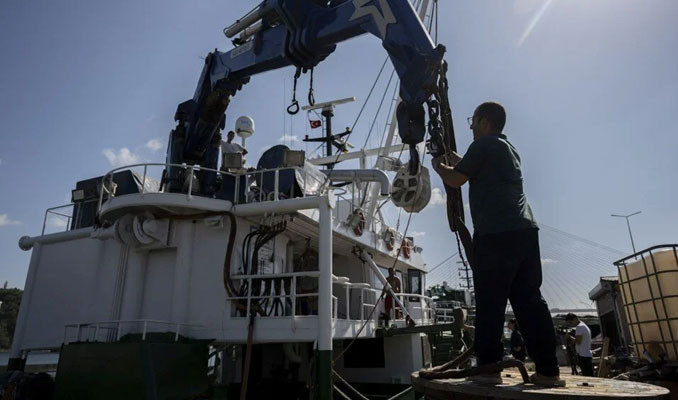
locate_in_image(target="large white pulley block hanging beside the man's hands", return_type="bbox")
[391,164,431,213]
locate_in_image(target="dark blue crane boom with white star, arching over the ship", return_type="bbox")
[167,0,445,194]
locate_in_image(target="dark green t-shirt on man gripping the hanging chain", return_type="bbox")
[454,134,537,235]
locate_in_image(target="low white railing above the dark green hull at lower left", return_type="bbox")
[64,319,197,344]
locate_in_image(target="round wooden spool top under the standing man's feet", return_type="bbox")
[412,369,669,400]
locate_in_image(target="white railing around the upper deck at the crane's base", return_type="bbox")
[97,163,329,210]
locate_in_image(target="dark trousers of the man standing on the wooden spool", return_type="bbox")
[473,229,559,376]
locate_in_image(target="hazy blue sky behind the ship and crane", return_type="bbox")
[0,0,678,290]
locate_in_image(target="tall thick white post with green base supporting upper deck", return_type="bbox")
[316,197,333,400]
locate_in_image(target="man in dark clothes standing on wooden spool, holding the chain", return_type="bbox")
[433,102,565,386]
